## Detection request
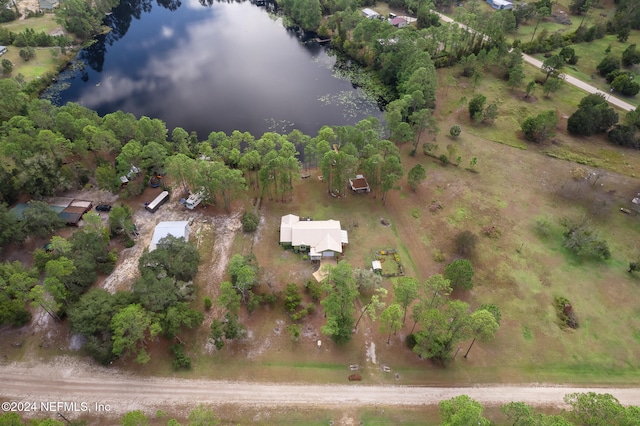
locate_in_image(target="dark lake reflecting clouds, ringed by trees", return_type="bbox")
[45,0,381,140]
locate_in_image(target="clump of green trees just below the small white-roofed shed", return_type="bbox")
[69,236,204,364]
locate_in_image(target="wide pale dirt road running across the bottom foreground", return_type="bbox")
[0,363,640,415]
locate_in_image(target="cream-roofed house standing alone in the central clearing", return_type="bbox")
[280,214,349,260]
